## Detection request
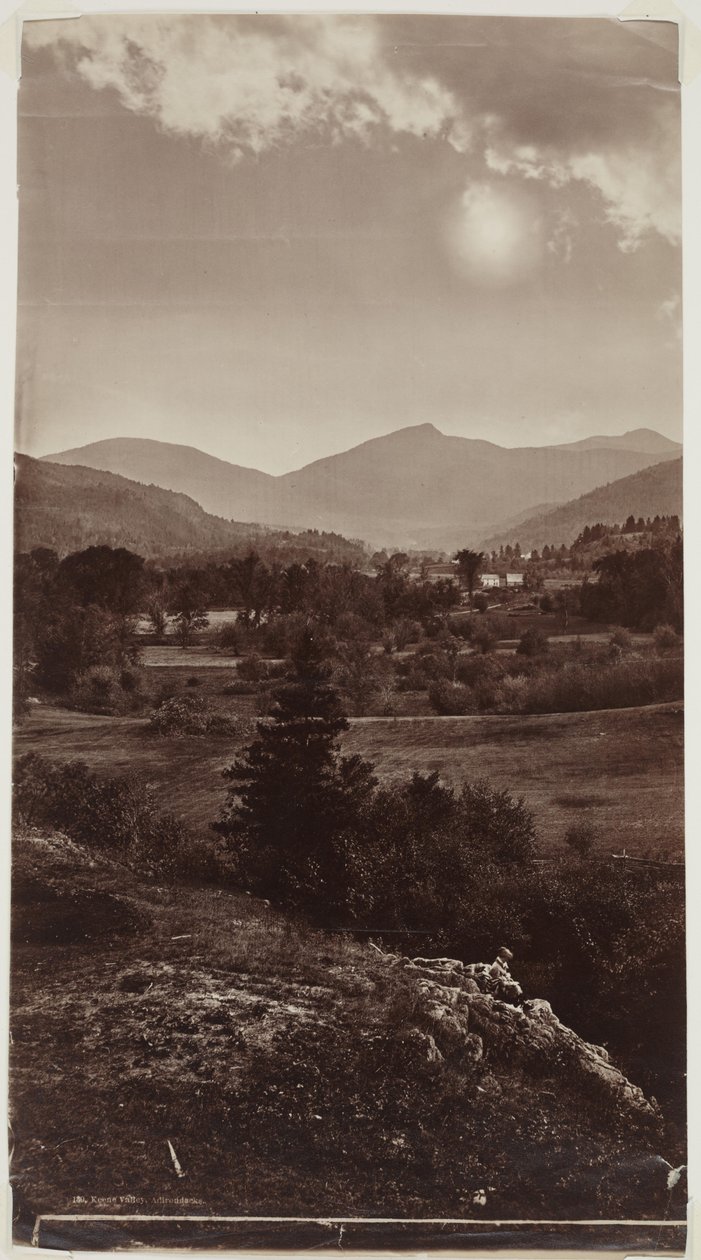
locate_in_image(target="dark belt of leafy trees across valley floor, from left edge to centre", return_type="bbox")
[15,547,459,692]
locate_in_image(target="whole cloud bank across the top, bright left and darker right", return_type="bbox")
[25,15,681,255]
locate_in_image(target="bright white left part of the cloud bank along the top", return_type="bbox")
[25,16,470,156]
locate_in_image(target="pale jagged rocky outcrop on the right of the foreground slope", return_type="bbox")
[385,954,659,1124]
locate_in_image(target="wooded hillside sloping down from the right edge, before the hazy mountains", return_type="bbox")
[482,459,682,549]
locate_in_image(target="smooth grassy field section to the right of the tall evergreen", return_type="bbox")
[344,703,683,854]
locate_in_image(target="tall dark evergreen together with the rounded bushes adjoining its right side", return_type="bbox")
[214,630,535,929]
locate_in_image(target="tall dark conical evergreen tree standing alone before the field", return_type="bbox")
[214,629,374,911]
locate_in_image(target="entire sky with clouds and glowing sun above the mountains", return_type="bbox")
[18,15,682,473]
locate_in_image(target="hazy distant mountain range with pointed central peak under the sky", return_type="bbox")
[44,423,681,548]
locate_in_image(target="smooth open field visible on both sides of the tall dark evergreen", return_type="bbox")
[15,697,683,856]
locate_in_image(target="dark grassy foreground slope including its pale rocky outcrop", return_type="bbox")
[11,834,678,1246]
